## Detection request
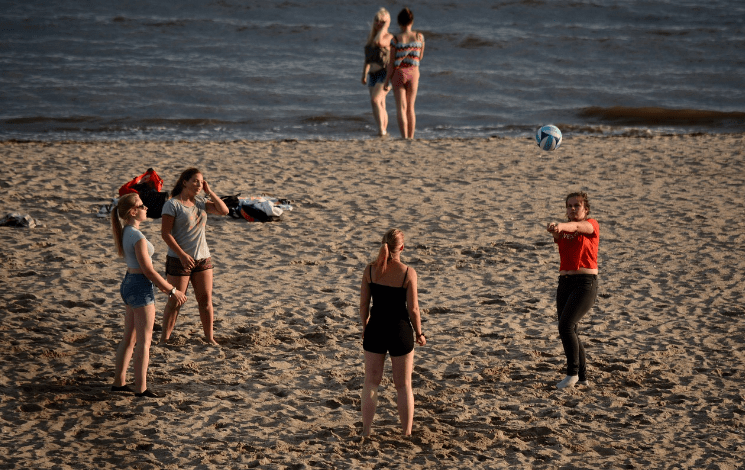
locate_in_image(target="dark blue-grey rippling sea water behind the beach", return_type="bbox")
[0,0,745,140]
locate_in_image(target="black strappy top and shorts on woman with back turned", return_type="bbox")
[362,266,414,357]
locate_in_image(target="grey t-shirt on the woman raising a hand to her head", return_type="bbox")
[163,197,210,260]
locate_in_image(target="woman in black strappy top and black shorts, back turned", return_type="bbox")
[360,229,427,436]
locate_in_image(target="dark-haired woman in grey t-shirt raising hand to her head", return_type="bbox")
[160,168,228,345]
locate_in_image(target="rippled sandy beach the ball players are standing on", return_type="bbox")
[0,134,745,470]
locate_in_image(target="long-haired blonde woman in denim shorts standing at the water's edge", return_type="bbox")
[362,8,393,136]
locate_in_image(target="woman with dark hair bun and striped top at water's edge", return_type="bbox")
[384,8,424,139]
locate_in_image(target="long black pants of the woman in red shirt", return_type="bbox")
[556,274,598,380]
